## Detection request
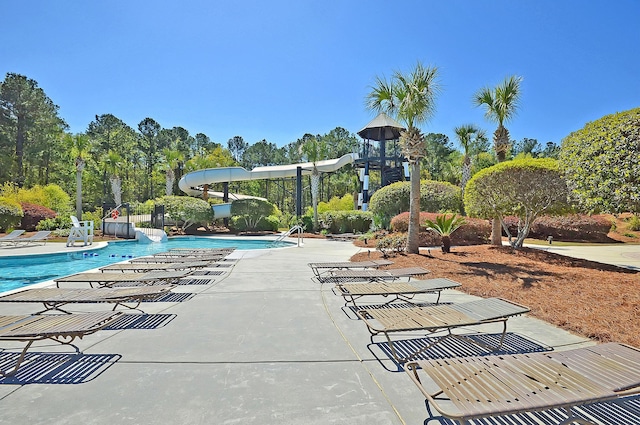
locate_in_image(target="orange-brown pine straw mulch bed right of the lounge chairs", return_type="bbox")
[351,244,640,347]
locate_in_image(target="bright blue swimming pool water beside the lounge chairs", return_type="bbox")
[0,237,291,292]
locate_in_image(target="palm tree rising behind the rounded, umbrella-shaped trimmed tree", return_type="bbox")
[473,75,522,246]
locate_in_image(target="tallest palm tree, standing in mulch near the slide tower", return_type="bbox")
[366,62,440,254]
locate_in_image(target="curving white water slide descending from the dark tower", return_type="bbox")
[178,153,358,218]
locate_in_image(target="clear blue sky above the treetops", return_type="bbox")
[0,0,640,151]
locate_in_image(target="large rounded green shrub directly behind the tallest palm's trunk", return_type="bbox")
[369,180,462,228]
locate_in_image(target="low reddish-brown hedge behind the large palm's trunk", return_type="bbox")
[391,212,491,246]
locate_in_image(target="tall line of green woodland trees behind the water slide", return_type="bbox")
[0,73,559,217]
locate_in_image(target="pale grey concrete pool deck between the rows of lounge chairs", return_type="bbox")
[0,239,640,425]
